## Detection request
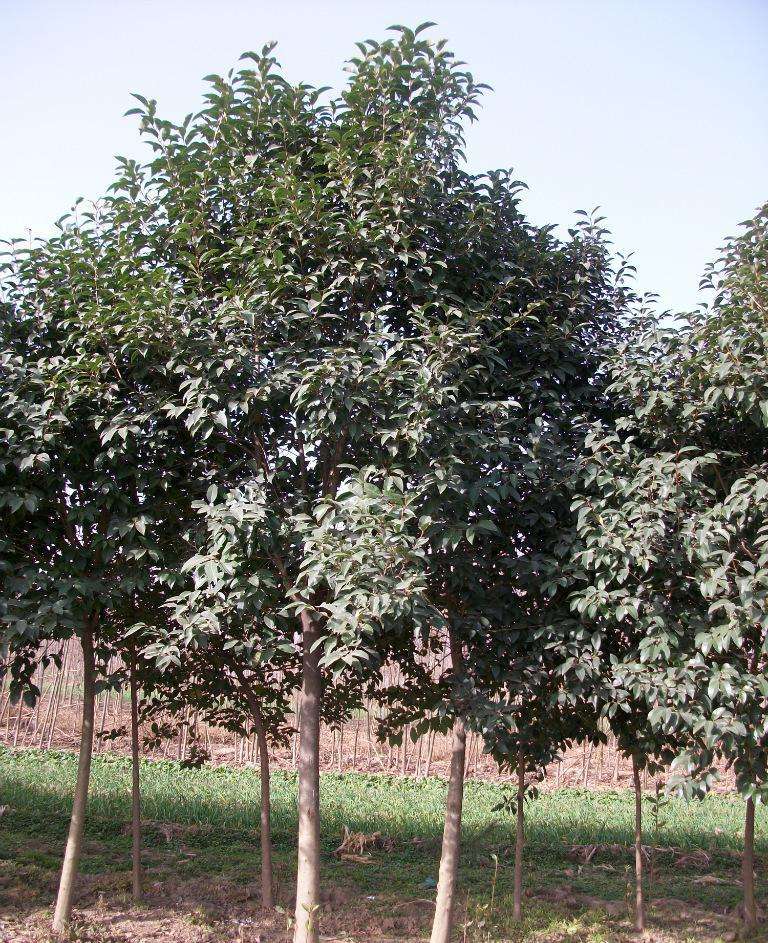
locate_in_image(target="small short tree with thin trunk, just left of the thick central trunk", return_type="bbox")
[142,485,300,909]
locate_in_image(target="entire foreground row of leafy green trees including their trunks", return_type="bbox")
[0,24,768,943]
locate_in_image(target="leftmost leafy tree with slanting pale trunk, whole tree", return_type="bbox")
[0,208,198,932]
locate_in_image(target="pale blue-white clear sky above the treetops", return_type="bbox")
[0,0,768,310]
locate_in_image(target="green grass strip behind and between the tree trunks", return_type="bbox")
[0,749,768,941]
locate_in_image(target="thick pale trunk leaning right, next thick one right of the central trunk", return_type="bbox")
[430,718,467,943]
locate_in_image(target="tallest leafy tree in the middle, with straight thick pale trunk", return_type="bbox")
[91,29,520,940]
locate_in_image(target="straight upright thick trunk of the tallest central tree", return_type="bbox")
[293,612,322,943]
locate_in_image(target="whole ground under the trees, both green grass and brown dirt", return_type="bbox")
[0,749,768,943]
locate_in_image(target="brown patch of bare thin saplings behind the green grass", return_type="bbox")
[0,641,696,793]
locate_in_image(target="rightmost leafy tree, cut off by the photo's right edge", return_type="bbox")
[660,204,768,929]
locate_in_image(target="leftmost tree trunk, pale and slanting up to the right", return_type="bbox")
[53,619,96,934]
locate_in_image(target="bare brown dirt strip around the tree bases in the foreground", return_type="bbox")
[0,862,756,943]
